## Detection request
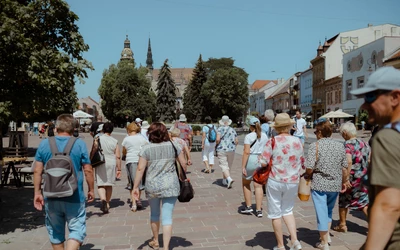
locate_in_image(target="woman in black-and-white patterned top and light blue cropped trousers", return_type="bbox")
[306,118,349,250]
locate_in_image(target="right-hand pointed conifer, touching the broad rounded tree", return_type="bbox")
[183,55,207,121]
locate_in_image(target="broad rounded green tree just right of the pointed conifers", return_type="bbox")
[201,68,249,121]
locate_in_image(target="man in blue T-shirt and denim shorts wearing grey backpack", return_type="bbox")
[33,114,94,249]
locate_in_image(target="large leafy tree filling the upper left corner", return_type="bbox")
[0,0,93,122]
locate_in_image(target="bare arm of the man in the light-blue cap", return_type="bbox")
[365,186,400,250]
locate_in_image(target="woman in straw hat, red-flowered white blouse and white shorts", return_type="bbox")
[260,113,305,250]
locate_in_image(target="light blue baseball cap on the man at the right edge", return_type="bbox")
[350,67,400,96]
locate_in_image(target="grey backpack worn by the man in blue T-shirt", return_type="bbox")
[43,136,78,198]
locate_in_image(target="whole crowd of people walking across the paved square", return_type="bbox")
[34,67,400,250]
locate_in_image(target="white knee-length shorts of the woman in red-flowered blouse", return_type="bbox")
[267,178,299,219]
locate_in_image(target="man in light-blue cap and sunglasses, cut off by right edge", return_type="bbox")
[351,67,400,250]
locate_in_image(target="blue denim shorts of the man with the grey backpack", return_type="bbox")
[45,199,86,244]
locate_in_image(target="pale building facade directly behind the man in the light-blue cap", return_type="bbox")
[342,36,400,118]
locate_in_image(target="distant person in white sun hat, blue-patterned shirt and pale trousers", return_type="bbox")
[216,115,239,189]
